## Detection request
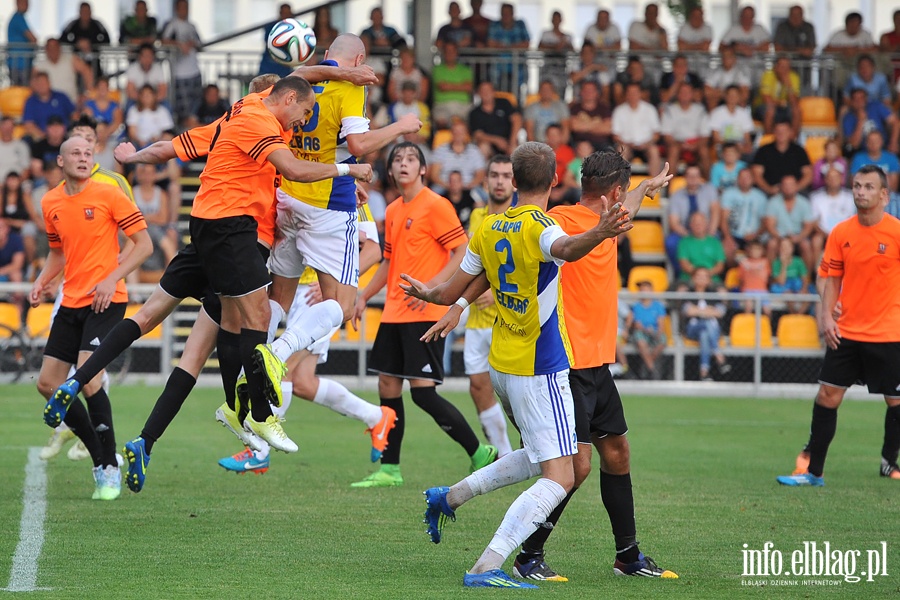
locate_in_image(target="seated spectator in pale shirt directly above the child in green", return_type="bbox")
[765,175,816,270]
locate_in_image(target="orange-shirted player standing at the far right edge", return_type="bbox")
[778,165,900,487]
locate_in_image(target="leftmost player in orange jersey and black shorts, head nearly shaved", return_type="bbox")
[29,137,153,500]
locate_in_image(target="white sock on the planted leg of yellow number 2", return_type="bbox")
[476,477,566,573]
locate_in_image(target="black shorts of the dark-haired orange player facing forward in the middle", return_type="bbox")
[368,321,444,383]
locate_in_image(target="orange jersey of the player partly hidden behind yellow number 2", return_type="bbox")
[549,204,619,369]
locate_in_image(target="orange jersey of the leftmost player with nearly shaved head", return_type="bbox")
[41,180,147,308]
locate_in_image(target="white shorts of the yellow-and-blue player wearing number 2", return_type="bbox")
[491,367,578,463]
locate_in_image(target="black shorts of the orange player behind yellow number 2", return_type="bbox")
[569,365,628,444]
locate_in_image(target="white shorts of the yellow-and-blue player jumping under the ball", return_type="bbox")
[269,189,359,287]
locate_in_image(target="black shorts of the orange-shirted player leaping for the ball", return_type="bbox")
[190,216,272,297]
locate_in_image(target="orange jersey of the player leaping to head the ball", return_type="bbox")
[186,94,291,245]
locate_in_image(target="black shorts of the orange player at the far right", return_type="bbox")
[819,338,900,398]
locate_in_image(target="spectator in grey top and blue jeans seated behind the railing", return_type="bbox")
[681,269,731,381]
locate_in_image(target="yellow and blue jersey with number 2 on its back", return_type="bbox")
[461,205,572,375]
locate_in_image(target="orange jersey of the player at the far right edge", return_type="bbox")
[819,213,900,342]
